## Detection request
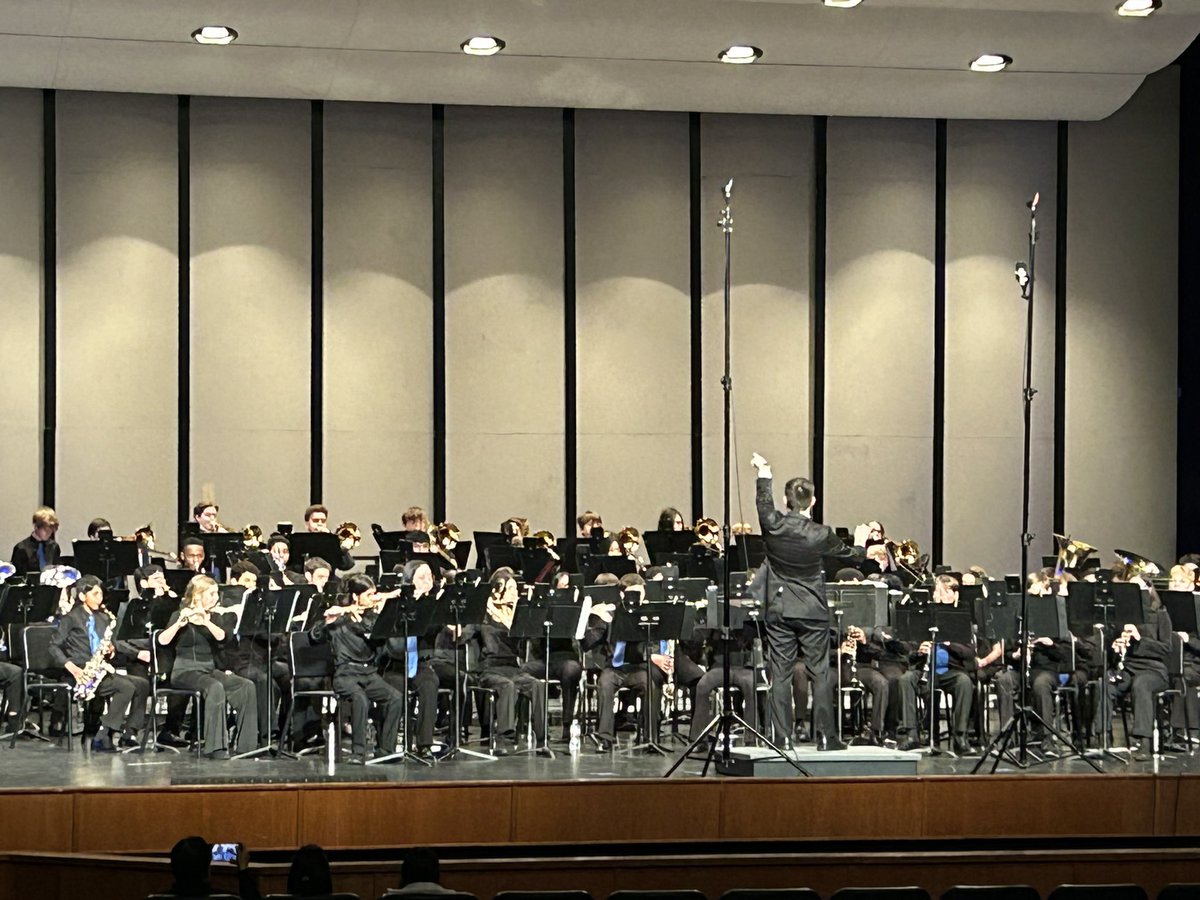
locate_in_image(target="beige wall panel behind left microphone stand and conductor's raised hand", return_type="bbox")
[701,115,812,530]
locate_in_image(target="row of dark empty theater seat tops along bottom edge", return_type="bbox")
[164,884,1200,900]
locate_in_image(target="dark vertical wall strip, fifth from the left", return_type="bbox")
[562,109,578,534]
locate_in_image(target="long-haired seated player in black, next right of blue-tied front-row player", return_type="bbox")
[461,566,546,756]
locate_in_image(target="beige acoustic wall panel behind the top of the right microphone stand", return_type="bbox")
[943,122,1057,574]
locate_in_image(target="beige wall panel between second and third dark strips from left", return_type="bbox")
[191,97,312,528]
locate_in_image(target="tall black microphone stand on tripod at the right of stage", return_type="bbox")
[969,193,1106,775]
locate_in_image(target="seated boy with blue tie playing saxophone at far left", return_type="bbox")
[49,575,150,750]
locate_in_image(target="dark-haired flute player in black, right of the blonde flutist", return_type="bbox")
[311,575,404,763]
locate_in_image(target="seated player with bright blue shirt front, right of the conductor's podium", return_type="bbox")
[899,575,978,756]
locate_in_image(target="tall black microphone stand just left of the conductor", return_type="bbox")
[662,178,806,778]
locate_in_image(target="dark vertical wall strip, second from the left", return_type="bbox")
[175,97,192,522]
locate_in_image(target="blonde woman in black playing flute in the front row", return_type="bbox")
[158,575,258,760]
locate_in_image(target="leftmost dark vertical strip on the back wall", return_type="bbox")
[42,90,59,506]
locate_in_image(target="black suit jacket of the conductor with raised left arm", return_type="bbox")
[755,478,863,623]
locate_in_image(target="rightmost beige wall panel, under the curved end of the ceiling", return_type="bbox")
[1064,68,1180,564]
